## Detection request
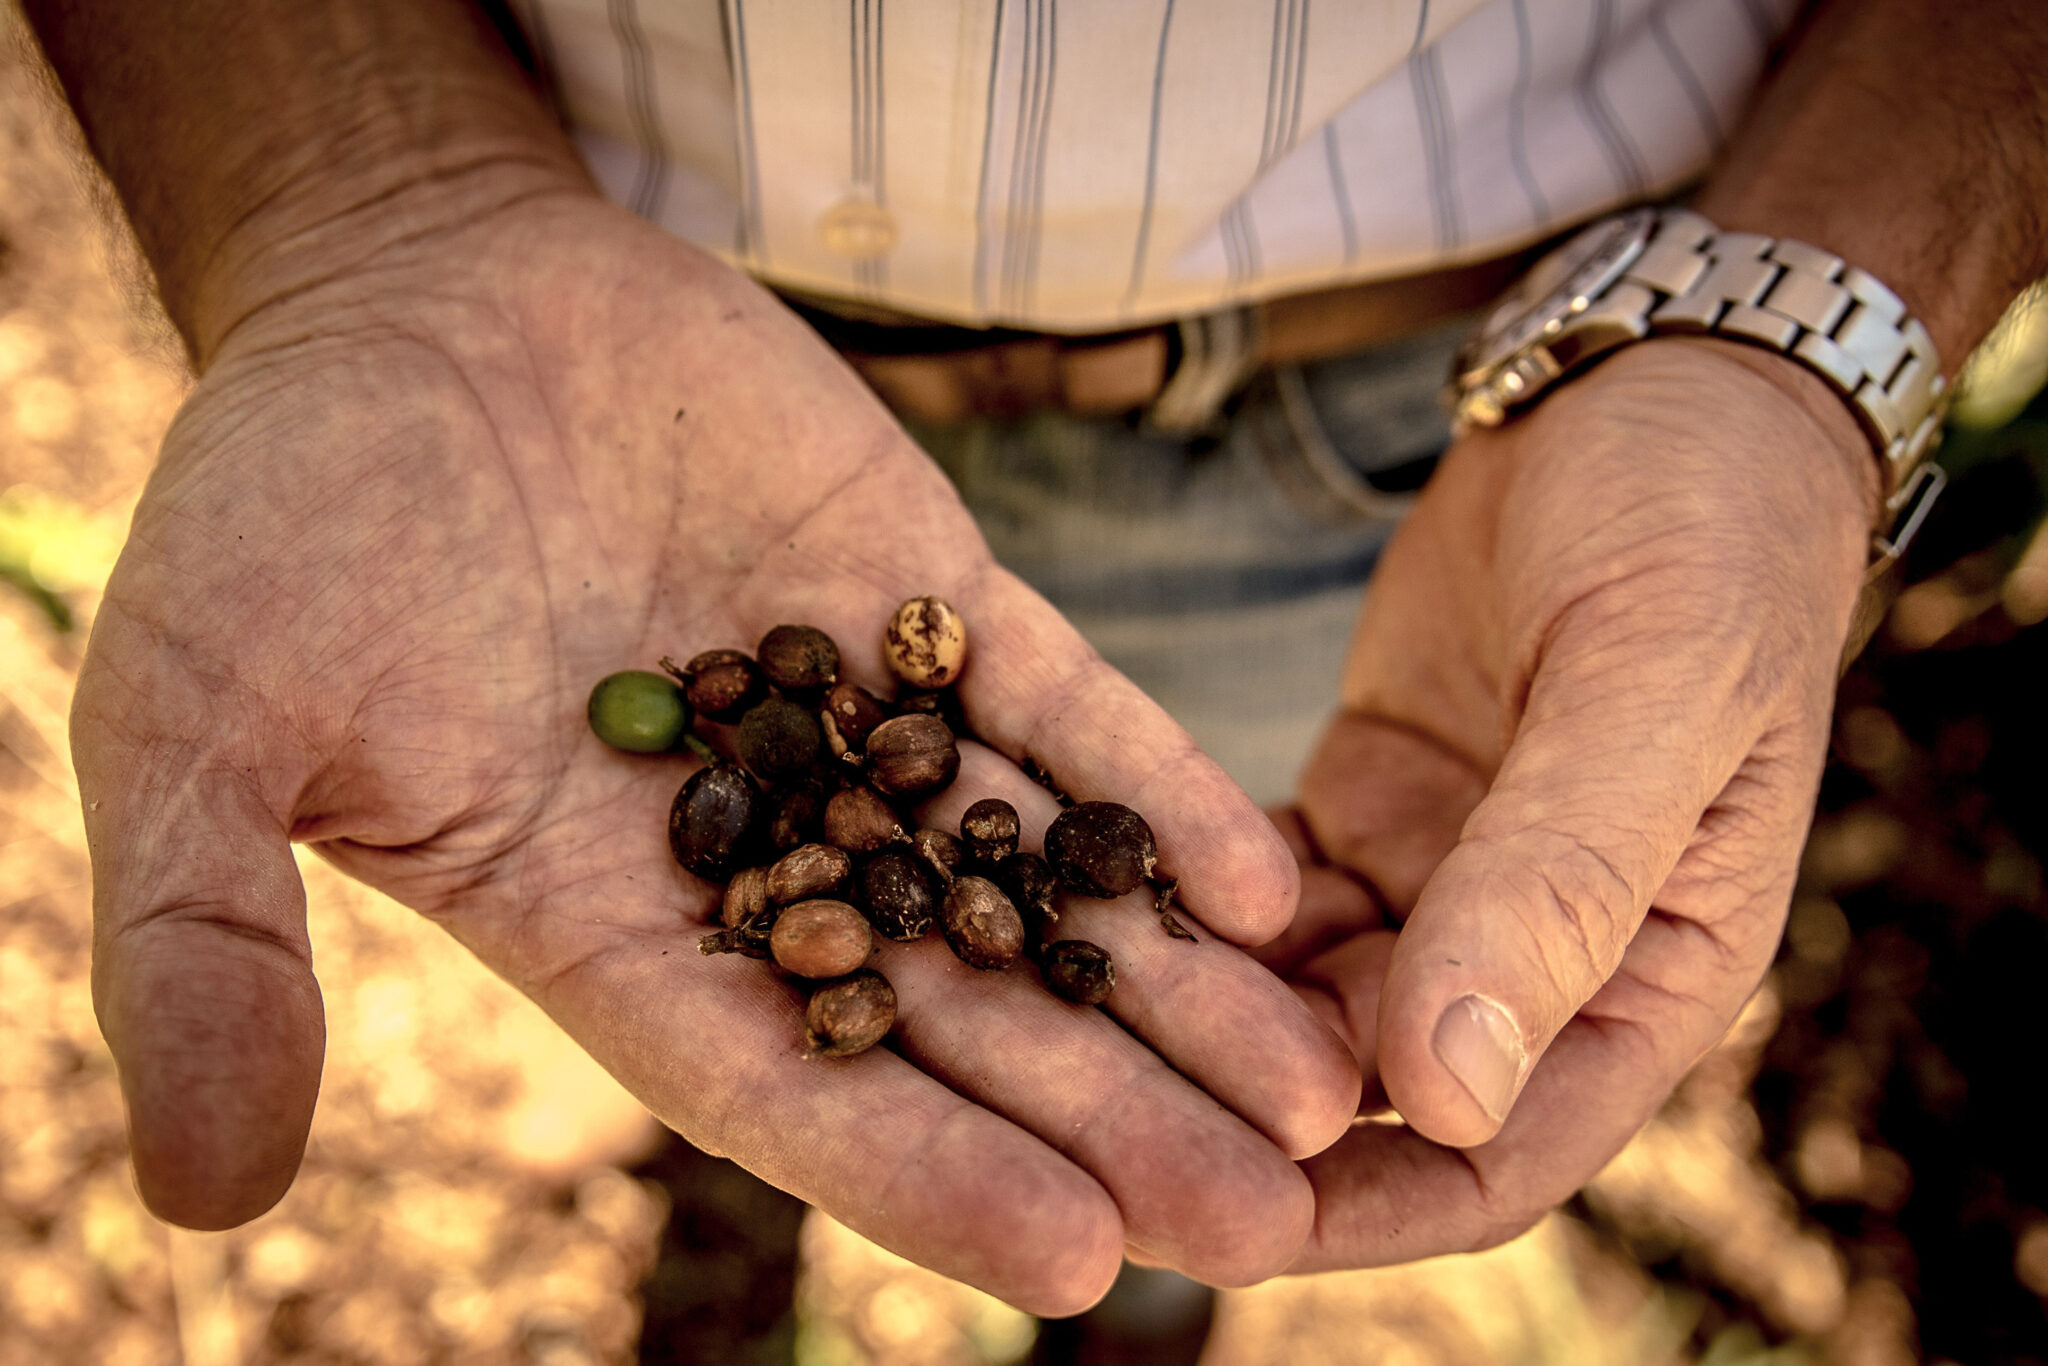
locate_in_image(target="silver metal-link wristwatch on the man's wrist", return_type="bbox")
[1446,209,1948,582]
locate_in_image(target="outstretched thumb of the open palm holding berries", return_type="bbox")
[72,684,326,1229]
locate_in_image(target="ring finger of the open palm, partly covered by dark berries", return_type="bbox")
[924,745,1360,1157]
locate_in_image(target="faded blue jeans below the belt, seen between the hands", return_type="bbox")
[911,319,1466,803]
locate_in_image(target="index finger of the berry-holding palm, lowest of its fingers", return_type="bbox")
[530,942,1122,1317]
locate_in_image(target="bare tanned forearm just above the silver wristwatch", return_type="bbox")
[1700,0,2048,373]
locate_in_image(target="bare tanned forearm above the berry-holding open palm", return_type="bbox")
[23,0,588,369]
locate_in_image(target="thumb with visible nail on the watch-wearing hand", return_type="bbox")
[1378,626,1745,1147]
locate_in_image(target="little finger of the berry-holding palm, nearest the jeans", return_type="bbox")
[961,569,1300,944]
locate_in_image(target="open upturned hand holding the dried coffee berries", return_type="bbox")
[74,193,1358,1313]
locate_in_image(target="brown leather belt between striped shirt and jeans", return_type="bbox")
[784,248,1542,432]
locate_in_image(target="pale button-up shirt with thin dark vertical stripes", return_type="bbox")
[510,0,1798,332]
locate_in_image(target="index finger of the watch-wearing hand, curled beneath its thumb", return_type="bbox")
[1290,917,1767,1272]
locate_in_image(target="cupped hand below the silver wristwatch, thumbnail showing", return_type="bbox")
[1264,340,1876,1270]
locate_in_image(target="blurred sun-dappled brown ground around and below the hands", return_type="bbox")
[0,10,2048,1366]
